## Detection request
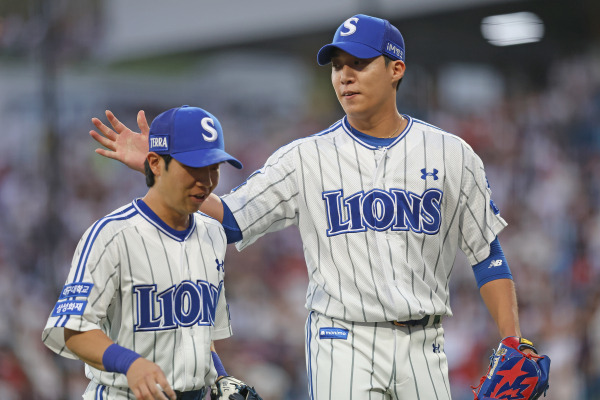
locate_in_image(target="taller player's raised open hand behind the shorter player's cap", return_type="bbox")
[90,110,150,173]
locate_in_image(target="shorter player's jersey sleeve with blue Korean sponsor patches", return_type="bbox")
[42,224,119,359]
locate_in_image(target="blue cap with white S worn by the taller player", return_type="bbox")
[317,14,404,65]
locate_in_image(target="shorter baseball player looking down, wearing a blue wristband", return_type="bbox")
[42,106,260,400]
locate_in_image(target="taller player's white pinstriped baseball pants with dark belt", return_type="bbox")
[305,312,451,400]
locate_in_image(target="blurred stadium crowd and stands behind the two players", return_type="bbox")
[0,0,600,400]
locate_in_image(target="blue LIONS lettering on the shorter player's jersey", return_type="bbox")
[133,280,223,332]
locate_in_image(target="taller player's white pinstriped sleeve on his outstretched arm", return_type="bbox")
[222,145,299,250]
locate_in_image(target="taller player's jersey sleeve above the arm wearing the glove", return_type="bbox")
[459,148,507,265]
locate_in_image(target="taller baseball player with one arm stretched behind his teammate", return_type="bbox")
[91,14,548,400]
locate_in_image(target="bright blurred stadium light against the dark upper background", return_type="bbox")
[481,12,544,46]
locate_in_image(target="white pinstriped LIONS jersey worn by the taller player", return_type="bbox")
[223,116,506,322]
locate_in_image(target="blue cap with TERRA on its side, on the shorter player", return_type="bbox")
[149,106,242,169]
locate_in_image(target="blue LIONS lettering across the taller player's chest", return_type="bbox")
[323,189,443,236]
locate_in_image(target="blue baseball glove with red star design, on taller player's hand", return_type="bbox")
[471,336,550,400]
